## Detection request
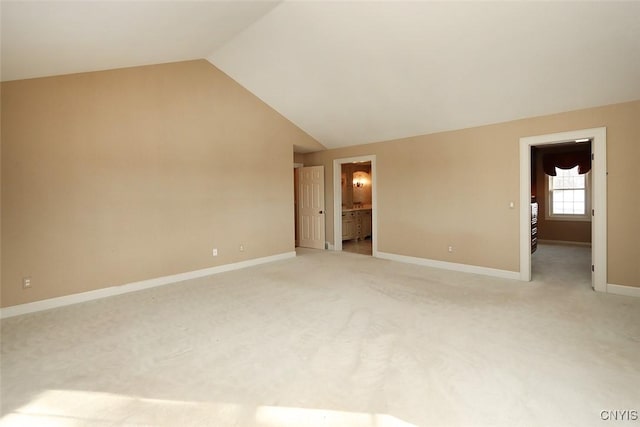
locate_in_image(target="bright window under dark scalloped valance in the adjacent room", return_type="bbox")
[548,166,589,220]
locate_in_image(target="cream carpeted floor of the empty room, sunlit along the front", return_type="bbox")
[0,246,640,427]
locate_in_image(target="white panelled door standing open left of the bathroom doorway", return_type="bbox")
[298,166,324,249]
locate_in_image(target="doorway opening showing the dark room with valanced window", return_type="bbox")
[531,142,593,289]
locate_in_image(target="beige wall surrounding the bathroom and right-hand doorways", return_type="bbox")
[305,101,640,286]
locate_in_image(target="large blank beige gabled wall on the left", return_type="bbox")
[1,60,322,307]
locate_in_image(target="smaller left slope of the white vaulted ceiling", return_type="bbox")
[1,0,278,81]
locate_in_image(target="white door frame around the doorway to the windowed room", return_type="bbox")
[520,127,607,292]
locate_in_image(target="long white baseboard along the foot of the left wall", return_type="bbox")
[0,251,296,319]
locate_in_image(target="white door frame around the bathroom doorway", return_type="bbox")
[333,155,378,257]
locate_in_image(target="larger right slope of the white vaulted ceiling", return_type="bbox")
[209,2,640,147]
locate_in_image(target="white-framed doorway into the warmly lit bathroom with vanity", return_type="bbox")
[333,156,377,256]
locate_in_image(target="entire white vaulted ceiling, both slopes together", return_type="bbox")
[1,0,640,148]
